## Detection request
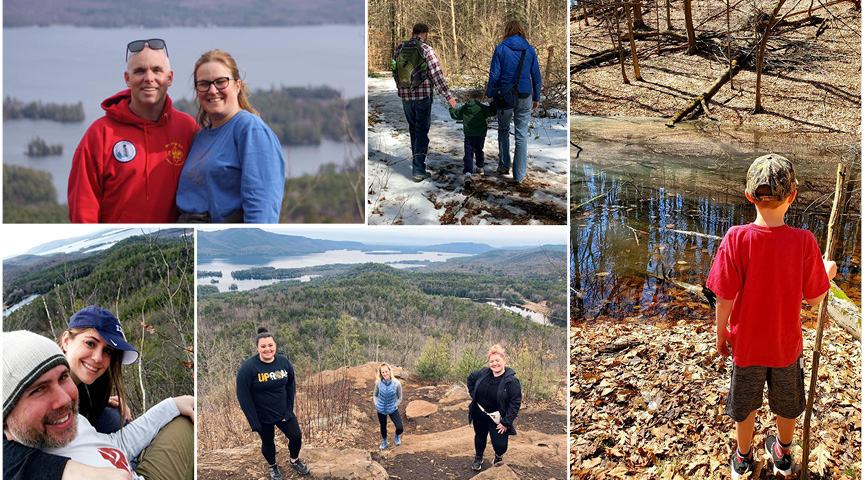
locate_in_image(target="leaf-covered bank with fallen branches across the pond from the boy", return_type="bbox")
[570,2,861,143]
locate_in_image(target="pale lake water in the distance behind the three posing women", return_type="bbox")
[197,250,470,292]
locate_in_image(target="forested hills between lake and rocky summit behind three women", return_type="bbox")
[198,264,566,375]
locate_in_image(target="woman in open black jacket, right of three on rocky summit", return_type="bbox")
[468,345,522,470]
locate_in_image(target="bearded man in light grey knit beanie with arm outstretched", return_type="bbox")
[2,331,194,480]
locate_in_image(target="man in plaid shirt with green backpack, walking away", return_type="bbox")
[390,23,456,182]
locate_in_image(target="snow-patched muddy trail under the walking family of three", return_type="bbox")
[366,75,569,225]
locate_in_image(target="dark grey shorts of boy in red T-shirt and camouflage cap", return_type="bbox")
[726,356,806,422]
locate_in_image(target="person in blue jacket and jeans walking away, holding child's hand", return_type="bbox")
[486,20,542,184]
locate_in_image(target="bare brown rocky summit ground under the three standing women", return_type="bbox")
[197,362,567,480]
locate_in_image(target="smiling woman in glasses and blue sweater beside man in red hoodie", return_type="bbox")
[177,50,285,223]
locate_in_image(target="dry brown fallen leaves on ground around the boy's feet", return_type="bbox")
[570,320,861,480]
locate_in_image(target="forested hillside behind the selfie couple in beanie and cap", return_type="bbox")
[3,230,195,415]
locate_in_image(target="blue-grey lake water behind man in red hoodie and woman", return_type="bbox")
[3,25,366,204]
